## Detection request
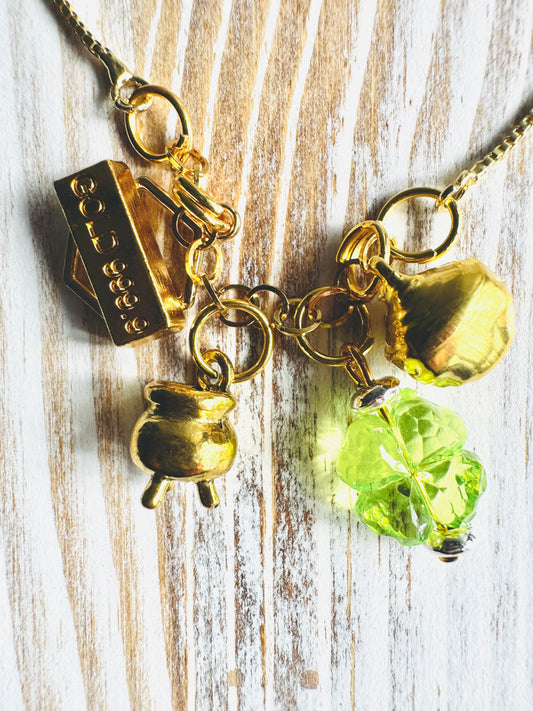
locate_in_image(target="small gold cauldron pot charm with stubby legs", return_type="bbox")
[131,381,237,509]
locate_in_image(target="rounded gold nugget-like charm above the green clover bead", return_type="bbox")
[370,257,514,386]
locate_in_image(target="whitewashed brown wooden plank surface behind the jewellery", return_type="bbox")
[0,0,533,711]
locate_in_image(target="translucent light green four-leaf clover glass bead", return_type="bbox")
[337,388,486,549]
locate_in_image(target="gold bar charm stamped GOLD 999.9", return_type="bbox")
[55,161,184,346]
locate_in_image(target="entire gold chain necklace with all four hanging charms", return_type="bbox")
[48,0,533,561]
